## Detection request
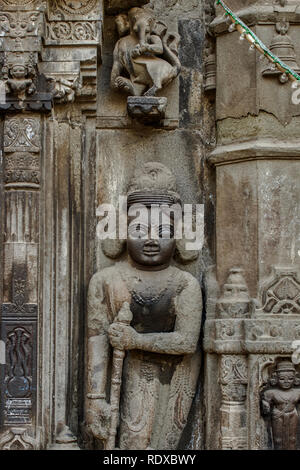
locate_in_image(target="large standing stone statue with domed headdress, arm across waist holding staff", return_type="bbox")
[86,163,202,450]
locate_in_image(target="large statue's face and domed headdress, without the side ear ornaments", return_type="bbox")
[127,162,181,269]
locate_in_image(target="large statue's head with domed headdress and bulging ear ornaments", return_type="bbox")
[102,162,199,269]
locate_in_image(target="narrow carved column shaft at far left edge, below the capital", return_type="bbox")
[1,115,41,449]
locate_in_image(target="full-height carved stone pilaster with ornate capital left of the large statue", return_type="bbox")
[0,0,102,449]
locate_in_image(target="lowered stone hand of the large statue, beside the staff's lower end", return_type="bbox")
[86,399,111,440]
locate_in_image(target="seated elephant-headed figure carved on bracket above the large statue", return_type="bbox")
[111,8,181,96]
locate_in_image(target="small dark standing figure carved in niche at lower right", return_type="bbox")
[261,360,300,450]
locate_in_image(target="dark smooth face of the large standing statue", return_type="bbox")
[127,208,176,269]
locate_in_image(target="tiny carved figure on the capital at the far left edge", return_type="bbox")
[2,54,36,101]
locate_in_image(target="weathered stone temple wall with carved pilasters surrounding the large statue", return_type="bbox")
[0,0,300,449]
